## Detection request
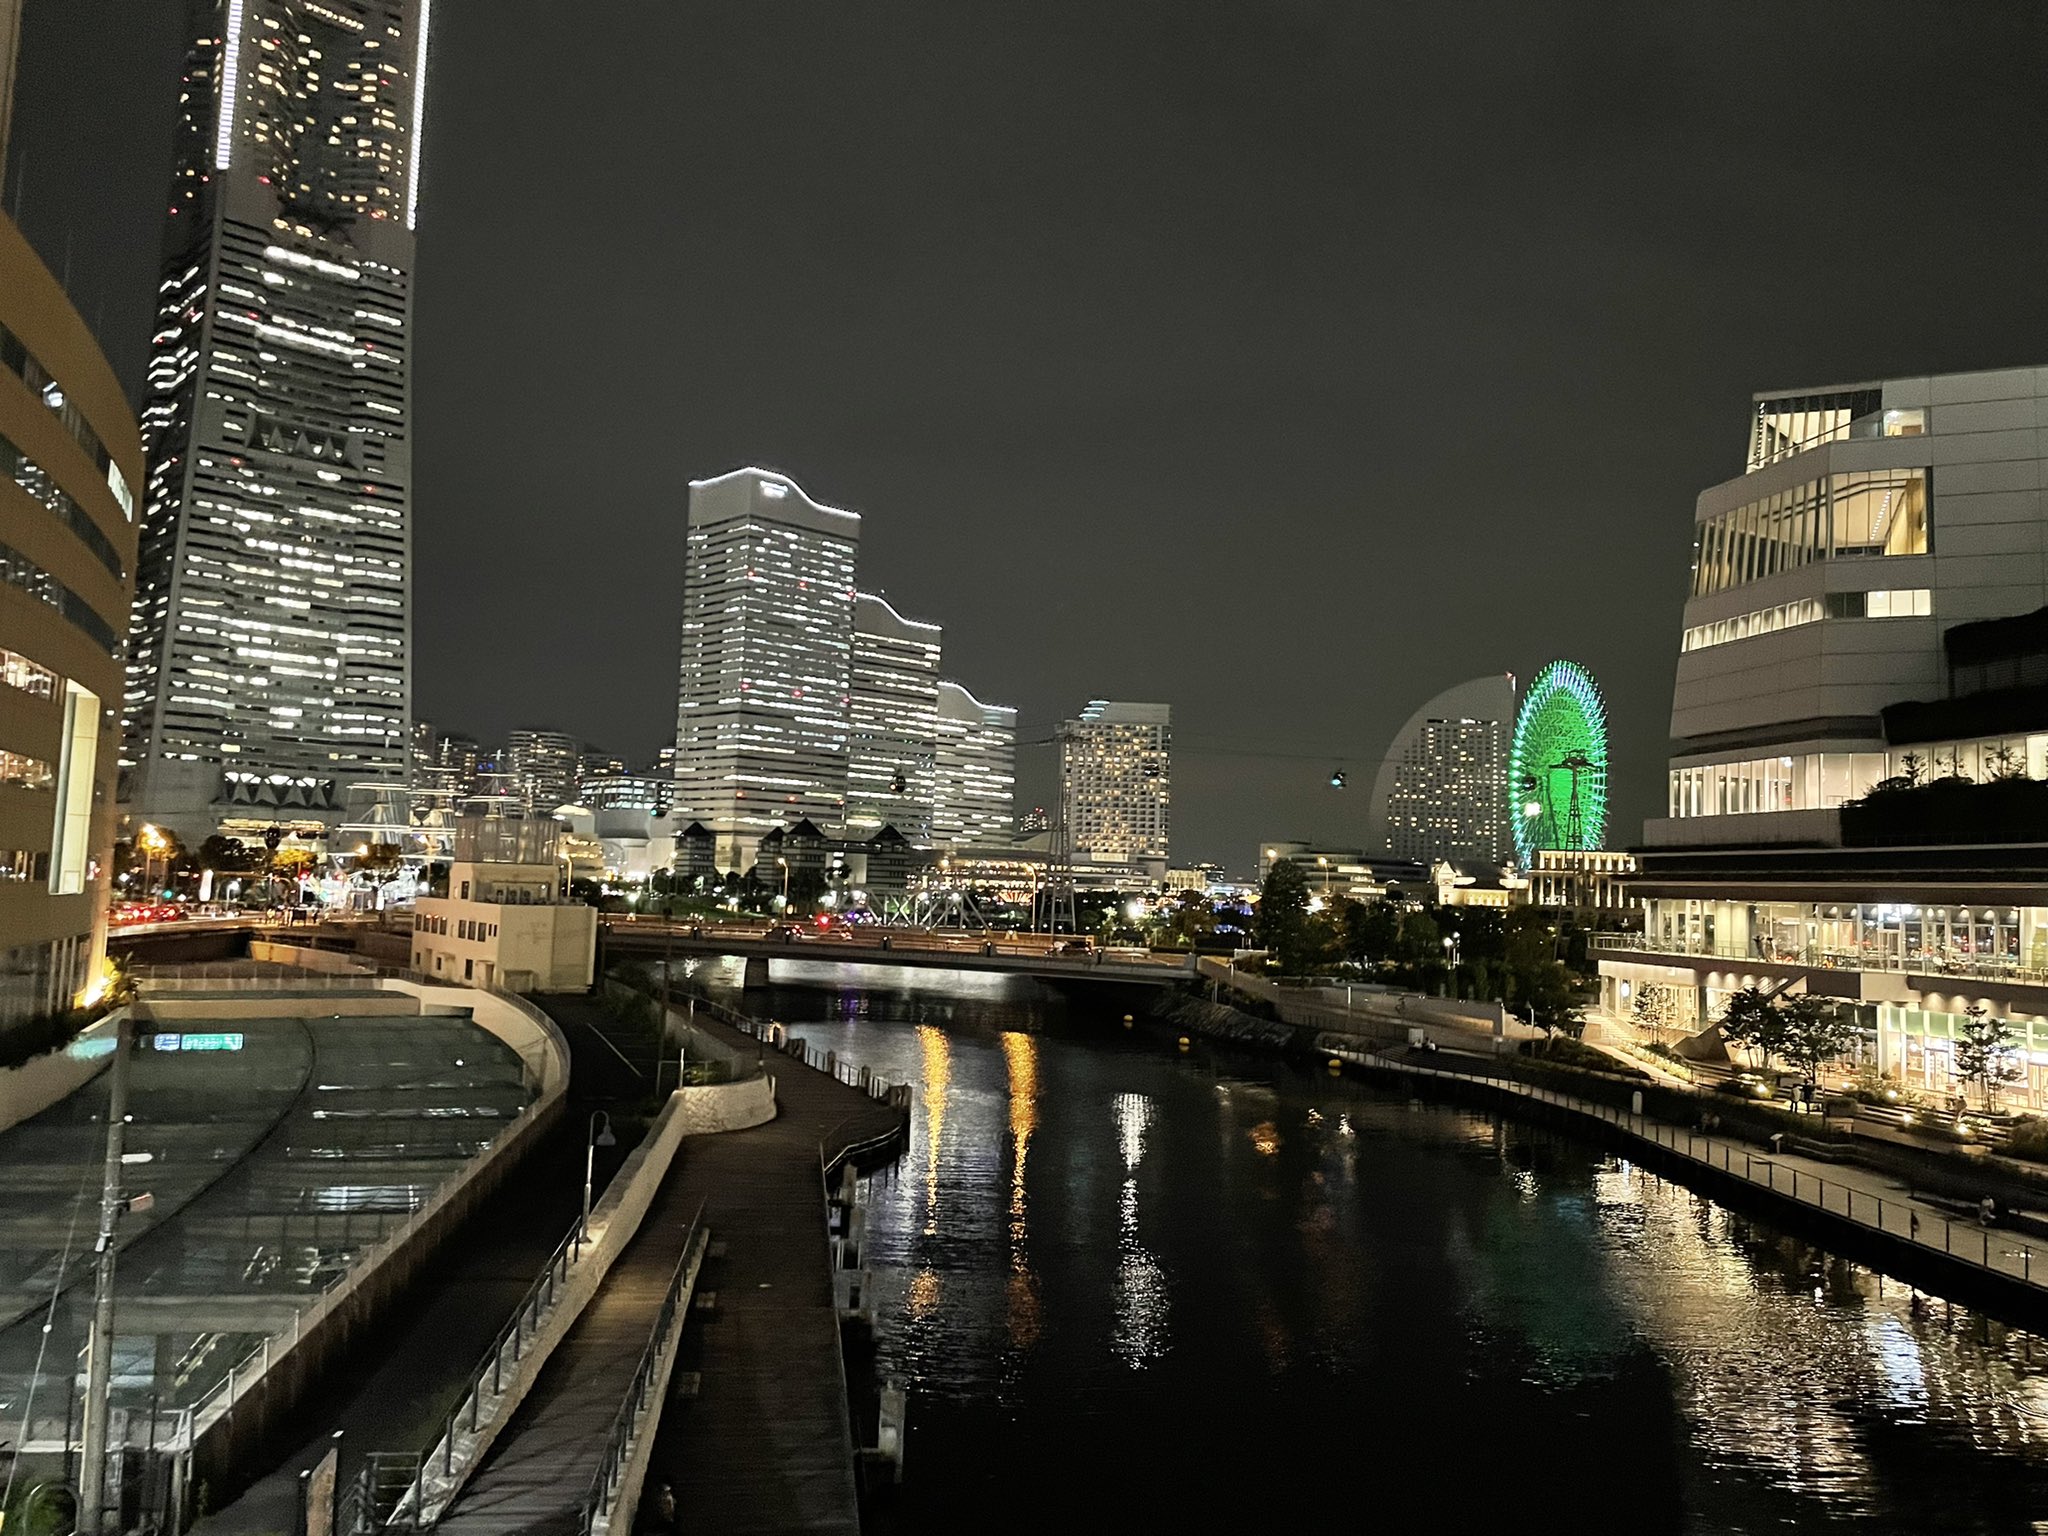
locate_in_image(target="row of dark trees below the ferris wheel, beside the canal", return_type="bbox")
[1253,860,1591,1034]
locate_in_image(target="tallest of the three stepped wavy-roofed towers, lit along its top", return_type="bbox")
[676,469,860,868]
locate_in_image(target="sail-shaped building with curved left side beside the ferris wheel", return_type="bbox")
[1368,672,1516,864]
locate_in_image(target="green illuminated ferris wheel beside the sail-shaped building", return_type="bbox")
[1507,662,1608,868]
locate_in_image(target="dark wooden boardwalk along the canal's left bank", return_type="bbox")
[440,997,903,1536]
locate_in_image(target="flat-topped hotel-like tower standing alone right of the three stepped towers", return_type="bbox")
[1057,698,1171,864]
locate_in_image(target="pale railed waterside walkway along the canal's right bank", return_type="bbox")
[1331,1047,2048,1294]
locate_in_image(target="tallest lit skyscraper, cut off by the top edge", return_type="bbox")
[125,0,428,840]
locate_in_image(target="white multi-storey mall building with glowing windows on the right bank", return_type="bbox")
[1597,369,2048,1108]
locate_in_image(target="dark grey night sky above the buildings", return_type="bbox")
[8,0,2048,866]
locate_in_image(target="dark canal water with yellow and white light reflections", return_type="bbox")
[708,965,2048,1534]
